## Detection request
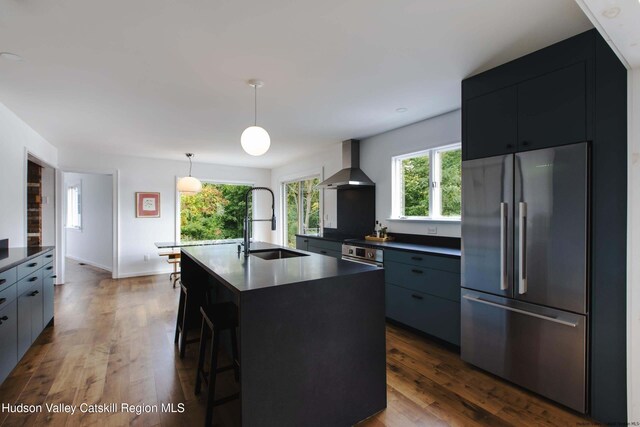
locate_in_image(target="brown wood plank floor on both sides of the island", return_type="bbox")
[0,262,590,427]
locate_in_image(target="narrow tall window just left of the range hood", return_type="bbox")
[282,177,320,247]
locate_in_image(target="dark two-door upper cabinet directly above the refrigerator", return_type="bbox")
[462,33,594,160]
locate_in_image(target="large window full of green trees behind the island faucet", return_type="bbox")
[180,182,252,241]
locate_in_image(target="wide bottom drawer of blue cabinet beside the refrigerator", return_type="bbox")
[385,284,460,345]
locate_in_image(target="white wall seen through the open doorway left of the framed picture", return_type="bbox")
[61,173,113,271]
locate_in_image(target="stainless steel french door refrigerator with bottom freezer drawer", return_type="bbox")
[460,143,589,413]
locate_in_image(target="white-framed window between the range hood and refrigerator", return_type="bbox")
[391,144,462,220]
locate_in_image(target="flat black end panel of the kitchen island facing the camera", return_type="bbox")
[240,269,386,426]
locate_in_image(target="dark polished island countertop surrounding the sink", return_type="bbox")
[182,242,378,293]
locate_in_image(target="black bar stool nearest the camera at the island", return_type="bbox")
[195,302,240,427]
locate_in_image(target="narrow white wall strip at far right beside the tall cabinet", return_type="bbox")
[627,67,640,422]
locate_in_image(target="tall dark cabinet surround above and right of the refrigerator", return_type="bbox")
[462,30,627,422]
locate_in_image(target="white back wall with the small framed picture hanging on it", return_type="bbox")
[59,149,271,277]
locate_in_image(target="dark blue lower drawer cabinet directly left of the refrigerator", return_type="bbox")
[384,250,460,345]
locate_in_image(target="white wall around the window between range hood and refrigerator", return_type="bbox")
[360,110,462,237]
